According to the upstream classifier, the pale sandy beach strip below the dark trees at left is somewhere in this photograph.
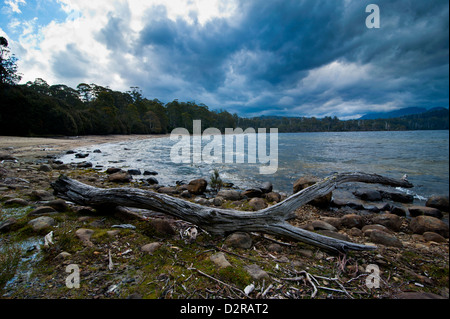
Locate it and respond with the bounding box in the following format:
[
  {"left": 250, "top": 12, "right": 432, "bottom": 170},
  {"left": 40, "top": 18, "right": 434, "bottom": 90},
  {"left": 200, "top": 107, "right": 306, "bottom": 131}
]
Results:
[{"left": 0, "top": 135, "right": 168, "bottom": 158}]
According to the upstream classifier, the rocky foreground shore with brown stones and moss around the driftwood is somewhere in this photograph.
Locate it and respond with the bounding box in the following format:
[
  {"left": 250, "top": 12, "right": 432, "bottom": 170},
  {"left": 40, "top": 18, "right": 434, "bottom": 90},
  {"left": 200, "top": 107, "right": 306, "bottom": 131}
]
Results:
[{"left": 0, "top": 139, "right": 449, "bottom": 299}]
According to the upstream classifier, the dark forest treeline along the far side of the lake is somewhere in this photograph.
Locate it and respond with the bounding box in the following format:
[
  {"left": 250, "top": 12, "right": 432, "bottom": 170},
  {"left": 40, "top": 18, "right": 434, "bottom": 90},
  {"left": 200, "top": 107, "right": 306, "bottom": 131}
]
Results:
[{"left": 0, "top": 79, "right": 449, "bottom": 136}]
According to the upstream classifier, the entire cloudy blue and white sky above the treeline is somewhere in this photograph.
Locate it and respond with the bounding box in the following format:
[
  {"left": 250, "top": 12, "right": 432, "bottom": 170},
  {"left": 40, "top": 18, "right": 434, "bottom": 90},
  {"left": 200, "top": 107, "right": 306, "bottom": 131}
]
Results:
[{"left": 0, "top": 0, "right": 449, "bottom": 119}]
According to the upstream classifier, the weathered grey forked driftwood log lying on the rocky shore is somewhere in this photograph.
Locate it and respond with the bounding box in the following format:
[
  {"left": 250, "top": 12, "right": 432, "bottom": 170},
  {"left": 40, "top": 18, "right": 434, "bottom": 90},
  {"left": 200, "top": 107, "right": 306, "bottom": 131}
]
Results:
[{"left": 51, "top": 173, "right": 413, "bottom": 253}]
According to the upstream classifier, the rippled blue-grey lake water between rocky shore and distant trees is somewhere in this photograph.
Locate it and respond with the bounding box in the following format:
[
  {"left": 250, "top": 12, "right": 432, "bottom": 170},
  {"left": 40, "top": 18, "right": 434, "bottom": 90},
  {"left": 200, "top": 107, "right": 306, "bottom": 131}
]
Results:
[{"left": 61, "top": 131, "right": 449, "bottom": 198}]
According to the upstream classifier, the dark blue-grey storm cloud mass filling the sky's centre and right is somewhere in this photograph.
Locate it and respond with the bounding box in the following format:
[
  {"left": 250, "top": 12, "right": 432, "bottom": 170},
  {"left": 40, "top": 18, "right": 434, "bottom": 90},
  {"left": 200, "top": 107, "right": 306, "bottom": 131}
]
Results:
[{"left": 96, "top": 0, "right": 449, "bottom": 116}]
